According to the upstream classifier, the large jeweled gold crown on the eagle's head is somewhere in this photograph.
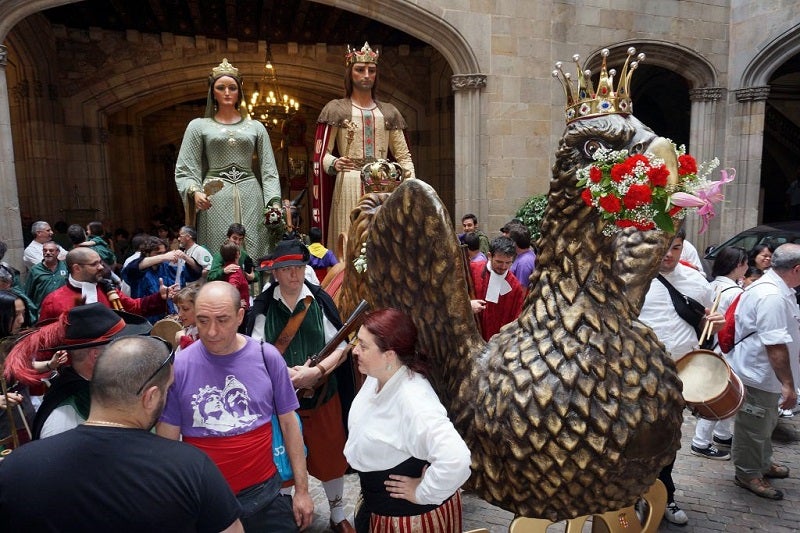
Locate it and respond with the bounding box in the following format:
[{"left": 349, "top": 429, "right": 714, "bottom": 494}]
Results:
[{"left": 553, "top": 47, "right": 645, "bottom": 124}]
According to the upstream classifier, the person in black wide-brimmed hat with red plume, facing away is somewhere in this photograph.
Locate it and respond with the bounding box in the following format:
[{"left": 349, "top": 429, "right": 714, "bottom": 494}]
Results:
[{"left": 31, "top": 303, "right": 152, "bottom": 439}]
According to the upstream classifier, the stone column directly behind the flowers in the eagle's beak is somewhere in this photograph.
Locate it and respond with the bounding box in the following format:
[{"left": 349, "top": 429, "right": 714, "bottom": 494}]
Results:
[{"left": 684, "top": 87, "right": 725, "bottom": 252}]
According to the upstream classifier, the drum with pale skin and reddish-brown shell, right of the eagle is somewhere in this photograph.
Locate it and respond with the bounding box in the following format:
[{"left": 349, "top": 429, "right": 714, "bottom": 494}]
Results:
[{"left": 675, "top": 350, "right": 744, "bottom": 420}]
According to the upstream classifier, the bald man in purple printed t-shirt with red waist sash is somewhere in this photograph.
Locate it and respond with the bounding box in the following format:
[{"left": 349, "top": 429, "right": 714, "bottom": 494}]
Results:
[{"left": 156, "top": 281, "right": 314, "bottom": 531}]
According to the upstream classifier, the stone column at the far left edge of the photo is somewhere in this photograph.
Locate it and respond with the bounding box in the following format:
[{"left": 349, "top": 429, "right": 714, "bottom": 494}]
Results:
[{"left": 0, "top": 44, "right": 24, "bottom": 270}]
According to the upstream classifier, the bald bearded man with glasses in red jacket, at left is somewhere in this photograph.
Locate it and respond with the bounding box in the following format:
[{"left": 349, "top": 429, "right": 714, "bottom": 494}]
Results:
[{"left": 39, "top": 247, "right": 168, "bottom": 322}]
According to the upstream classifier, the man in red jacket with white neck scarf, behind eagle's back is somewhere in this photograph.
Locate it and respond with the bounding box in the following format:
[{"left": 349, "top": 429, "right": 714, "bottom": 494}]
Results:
[{"left": 469, "top": 237, "right": 525, "bottom": 341}]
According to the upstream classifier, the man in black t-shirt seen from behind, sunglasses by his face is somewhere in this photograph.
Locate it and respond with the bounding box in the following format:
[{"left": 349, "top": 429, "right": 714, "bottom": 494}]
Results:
[{"left": 0, "top": 336, "right": 243, "bottom": 533}]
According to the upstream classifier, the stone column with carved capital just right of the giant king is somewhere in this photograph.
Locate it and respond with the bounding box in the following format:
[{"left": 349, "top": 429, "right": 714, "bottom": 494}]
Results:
[{"left": 450, "top": 74, "right": 489, "bottom": 227}]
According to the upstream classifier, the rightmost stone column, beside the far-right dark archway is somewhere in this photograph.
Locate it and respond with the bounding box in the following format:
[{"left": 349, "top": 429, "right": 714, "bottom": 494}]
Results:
[{"left": 722, "top": 86, "right": 769, "bottom": 236}]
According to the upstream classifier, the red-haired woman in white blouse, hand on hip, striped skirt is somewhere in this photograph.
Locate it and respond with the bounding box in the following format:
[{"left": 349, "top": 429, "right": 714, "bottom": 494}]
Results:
[{"left": 344, "top": 309, "right": 470, "bottom": 533}]
